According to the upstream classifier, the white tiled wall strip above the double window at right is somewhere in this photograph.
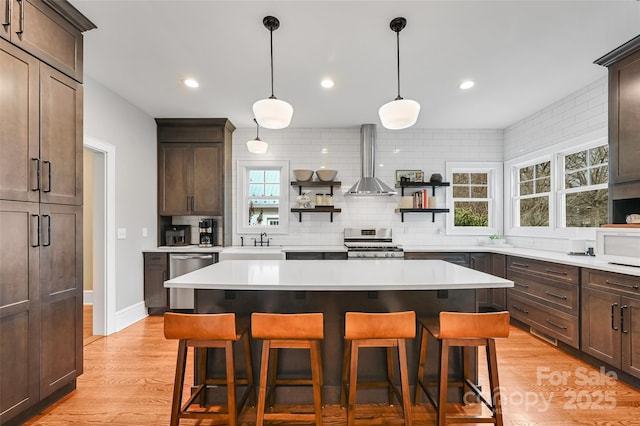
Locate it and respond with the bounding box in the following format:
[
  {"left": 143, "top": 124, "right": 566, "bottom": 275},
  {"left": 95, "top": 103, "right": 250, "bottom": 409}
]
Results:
[{"left": 504, "top": 77, "right": 608, "bottom": 161}]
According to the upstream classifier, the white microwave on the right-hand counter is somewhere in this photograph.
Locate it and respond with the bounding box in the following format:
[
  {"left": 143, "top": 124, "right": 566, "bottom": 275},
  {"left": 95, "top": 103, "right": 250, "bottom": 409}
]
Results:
[{"left": 596, "top": 225, "right": 640, "bottom": 266}]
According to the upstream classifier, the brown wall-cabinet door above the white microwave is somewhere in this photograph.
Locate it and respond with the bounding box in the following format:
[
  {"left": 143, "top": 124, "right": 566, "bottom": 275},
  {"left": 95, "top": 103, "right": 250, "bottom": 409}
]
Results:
[{"left": 609, "top": 52, "right": 640, "bottom": 183}]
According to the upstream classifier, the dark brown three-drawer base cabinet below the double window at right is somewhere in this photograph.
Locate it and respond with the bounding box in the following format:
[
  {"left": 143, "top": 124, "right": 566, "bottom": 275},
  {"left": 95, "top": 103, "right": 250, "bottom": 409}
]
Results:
[{"left": 507, "top": 256, "right": 580, "bottom": 348}]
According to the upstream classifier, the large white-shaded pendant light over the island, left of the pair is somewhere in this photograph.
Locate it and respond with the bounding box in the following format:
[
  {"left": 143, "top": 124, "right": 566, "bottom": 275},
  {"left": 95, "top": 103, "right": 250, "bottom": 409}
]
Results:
[{"left": 253, "top": 16, "right": 293, "bottom": 129}]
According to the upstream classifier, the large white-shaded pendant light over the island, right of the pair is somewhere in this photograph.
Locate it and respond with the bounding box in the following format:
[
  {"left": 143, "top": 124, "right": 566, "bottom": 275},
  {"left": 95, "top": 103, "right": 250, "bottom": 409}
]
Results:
[{"left": 378, "top": 18, "right": 420, "bottom": 130}]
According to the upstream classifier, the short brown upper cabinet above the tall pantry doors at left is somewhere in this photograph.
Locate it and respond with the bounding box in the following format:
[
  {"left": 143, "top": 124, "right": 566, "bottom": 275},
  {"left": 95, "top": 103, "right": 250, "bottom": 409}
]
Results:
[{"left": 0, "top": 0, "right": 95, "bottom": 82}]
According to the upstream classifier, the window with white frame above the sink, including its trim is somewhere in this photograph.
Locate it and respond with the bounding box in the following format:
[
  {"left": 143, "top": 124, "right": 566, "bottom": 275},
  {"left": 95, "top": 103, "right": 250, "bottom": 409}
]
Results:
[{"left": 237, "top": 161, "right": 289, "bottom": 233}]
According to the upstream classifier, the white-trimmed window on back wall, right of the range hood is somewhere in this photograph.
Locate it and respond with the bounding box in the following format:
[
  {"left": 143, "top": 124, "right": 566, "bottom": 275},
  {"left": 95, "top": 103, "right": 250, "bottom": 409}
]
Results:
[{"left": 447, "top": 163, "right": 502, "bottom": 235}]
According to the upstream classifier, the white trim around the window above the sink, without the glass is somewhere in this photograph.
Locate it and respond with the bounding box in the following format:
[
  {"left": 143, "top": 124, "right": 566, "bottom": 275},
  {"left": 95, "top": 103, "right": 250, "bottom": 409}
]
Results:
[{"left": 236, "top": 160, "right": 289, "bottom": 234}]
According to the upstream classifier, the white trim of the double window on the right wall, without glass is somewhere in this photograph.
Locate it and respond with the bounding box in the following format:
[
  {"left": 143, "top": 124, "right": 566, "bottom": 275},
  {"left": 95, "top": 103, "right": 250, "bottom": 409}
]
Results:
[{"left": 504, "top": 128, "right": 608, "bottom": 240}]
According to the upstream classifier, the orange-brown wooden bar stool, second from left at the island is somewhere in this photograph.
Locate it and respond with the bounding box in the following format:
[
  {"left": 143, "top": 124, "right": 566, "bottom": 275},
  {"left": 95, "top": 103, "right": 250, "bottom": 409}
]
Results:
[{"left": 251, "top": 313, "right": 324, "bottom": 426}]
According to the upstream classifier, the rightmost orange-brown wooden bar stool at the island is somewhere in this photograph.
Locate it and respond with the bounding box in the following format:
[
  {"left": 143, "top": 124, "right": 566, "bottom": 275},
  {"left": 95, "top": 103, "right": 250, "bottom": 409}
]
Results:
[{"left": 415, "top": 312, "right": 509, "bottom": 426}]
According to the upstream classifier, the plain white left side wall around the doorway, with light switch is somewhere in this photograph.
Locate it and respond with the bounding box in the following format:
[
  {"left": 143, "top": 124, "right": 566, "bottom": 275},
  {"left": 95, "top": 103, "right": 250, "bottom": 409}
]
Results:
[{"left": 84, "top": 75, "right": 157, "bottom": 311}]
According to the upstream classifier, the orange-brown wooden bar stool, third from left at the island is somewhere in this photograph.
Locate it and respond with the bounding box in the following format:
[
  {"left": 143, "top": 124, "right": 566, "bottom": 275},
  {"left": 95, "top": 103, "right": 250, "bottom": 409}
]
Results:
[{"left": 340, "top": 311, "right": 416, "bottom": 426}]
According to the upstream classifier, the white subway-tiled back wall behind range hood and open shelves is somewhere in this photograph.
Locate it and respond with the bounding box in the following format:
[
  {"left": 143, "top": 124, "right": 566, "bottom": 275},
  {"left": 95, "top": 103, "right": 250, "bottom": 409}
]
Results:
[{"left": 233, "top": 125, "right": 503, "bottom": 245}]
